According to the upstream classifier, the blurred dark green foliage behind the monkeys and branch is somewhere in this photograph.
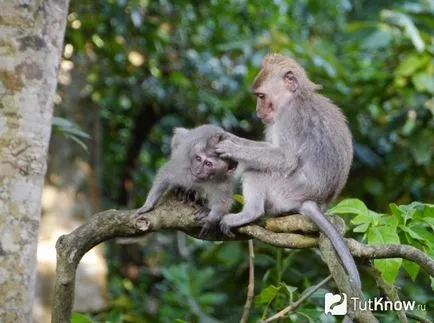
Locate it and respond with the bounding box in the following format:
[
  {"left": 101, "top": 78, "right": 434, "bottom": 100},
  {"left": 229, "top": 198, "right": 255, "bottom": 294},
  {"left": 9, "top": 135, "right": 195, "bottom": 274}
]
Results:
[{"left": 55, "top": 0, "right": 434, "bottom": 322}]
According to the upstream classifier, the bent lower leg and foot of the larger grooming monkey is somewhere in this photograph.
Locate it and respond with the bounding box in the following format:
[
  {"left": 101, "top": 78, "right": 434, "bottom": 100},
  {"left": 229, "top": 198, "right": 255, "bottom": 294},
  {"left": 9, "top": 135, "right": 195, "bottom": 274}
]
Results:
[{"left": 220, "top": 173, "right": 266, "bottom": 236}]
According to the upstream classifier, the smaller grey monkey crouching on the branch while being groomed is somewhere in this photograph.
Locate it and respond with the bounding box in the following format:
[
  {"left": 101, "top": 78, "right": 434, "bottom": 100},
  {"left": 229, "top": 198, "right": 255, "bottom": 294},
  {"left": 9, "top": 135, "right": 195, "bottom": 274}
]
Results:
[{"left": 136, "top": 125, "right": 237, "bottom": 234}]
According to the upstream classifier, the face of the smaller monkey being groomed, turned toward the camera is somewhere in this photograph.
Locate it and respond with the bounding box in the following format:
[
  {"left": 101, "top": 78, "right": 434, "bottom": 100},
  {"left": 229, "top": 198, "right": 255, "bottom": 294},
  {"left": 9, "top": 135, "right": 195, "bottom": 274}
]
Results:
[{"left": 190, "top": 152, "right": 235, "bottom": 182}]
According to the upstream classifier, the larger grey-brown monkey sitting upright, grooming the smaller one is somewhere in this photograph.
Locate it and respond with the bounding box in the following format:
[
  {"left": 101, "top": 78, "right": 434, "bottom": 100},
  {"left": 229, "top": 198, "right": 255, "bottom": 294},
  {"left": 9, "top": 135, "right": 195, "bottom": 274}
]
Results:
[{"left": 217, "top": 54, "right": 361, "bottom": 288}]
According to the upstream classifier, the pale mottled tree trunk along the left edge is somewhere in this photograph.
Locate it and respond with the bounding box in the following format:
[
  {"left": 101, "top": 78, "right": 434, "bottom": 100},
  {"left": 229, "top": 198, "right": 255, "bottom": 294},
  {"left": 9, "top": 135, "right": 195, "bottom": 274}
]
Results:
[{"left": 0, "top": 0, "right": 68, "bottom": 323}]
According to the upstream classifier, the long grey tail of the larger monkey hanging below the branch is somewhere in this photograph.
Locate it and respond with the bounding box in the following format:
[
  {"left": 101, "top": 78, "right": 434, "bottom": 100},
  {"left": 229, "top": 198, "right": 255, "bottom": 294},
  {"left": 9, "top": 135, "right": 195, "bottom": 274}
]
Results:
[{"left": 300, "top": 201, "right": 362, "bottom": 289}]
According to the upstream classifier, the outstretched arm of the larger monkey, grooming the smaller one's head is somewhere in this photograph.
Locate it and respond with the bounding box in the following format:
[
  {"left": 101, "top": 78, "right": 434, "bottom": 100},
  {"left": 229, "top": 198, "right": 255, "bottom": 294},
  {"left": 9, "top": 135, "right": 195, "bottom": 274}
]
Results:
[{"left": 216, "top": 140, "right": 298, "bottom": 175}]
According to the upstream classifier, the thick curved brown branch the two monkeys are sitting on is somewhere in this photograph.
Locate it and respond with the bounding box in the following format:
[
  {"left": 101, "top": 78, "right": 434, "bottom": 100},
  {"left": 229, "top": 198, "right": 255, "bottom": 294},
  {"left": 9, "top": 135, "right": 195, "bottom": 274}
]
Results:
[{"left": 52, "top": 198, "right": 434, "bottom": 323}]
